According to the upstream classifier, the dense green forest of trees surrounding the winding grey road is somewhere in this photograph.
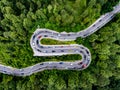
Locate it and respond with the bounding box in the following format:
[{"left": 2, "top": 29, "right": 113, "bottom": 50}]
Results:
[{"left": 0, "top": 0, "right": 120, "bottom": 90}]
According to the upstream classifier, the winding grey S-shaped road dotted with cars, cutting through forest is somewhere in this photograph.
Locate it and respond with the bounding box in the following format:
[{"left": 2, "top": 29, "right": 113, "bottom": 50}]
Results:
[{"left": 0, "top": 5, "right": 120, "bottom": 76}]
